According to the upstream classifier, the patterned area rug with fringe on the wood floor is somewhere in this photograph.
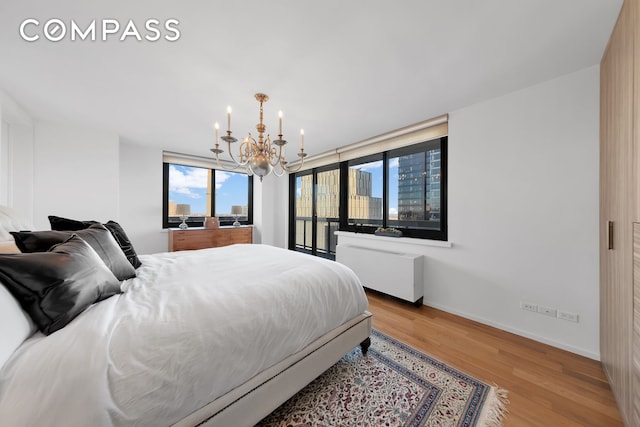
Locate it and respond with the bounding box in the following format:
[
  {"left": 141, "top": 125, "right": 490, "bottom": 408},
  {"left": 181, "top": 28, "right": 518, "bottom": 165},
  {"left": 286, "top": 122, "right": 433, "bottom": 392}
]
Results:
[{"left": 258, "top": 330, "right": 508, "bottom": 427}]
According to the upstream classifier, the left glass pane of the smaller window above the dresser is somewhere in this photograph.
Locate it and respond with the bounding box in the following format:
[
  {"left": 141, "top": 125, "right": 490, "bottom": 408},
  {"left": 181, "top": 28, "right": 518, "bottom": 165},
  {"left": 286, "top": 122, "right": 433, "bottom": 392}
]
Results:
[{"left": 167, "top": 164, "right": 211, "bottom": 226}]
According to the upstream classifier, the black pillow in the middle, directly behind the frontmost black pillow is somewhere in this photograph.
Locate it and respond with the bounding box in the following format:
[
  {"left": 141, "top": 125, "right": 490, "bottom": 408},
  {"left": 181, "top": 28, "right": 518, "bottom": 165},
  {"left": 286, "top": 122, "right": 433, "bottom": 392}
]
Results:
[{"left": 11, "top": 224, "right": 136, "bottom": 280}]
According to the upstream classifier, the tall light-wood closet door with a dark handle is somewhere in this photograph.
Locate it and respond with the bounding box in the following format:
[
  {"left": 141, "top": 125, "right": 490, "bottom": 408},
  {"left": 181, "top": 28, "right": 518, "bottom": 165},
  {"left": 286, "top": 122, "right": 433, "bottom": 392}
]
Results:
[{"left": 600, "top": 0, "right": 640, "bottom": 425}]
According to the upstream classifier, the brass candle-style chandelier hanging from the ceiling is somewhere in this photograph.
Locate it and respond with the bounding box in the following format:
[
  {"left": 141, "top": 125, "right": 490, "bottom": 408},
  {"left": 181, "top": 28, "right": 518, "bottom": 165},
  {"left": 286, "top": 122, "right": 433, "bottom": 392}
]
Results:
[{"left": 211, "top": 93, "right": 307, "bottom": 181}]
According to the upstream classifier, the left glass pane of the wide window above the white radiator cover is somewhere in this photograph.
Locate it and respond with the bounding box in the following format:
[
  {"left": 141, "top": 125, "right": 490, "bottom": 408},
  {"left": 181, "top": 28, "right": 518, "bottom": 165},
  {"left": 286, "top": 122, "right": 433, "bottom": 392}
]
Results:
[{"left": 347, "top": 159, "right": 383, "bottom": 226}]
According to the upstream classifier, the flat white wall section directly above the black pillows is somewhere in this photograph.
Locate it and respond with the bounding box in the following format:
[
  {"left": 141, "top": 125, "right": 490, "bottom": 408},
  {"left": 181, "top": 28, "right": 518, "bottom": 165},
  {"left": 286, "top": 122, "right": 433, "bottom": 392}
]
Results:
[{"left": 34, "top": 122, "right": 120, "bottom": 229}]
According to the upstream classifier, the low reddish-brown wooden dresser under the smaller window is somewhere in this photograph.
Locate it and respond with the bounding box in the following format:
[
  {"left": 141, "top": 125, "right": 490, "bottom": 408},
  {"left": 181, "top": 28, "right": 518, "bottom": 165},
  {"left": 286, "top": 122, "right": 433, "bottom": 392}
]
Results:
[{"left": 169, "top": 226, "right": 253, "bottom": 252}]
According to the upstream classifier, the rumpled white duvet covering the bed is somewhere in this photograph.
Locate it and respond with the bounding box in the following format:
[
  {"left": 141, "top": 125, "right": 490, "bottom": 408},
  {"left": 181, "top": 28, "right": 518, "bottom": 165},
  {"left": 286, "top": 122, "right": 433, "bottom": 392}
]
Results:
[{"left": 0, "top": 245, "right": 367, "bottom": 427}]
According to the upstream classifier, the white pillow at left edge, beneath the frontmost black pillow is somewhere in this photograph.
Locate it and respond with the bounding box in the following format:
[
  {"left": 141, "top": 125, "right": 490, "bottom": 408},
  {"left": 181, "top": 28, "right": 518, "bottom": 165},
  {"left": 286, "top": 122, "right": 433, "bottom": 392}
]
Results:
[{"left": 0, "top": 283, "right": 36, "bottom": 369}]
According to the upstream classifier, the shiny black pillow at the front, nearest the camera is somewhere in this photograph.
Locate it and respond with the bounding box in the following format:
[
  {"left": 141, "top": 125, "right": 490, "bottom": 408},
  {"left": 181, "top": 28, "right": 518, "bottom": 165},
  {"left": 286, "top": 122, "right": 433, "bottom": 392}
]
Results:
[{"left": 0, "top": 234, "right": 121, "bottom": 335}]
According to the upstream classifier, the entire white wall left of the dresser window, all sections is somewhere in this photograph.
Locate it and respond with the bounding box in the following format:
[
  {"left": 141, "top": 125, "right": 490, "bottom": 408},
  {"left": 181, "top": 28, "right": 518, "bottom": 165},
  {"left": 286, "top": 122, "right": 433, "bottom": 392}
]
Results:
[{"left": 0, "top": 103, "right": 167, "bottom": 254}]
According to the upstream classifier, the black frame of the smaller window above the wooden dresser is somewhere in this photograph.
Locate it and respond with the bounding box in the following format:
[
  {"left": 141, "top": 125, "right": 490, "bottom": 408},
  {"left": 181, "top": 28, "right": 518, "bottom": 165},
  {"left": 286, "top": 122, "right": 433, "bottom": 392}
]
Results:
[{"left": 162, "top": 162, "right": 253, "bottom": 229}]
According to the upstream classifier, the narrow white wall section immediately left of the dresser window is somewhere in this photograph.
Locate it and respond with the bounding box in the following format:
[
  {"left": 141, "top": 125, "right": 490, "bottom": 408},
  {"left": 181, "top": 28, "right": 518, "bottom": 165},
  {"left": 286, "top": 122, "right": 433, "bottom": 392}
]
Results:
[{"left": 119, "top": 143, "right": 168, "bottom": 254}]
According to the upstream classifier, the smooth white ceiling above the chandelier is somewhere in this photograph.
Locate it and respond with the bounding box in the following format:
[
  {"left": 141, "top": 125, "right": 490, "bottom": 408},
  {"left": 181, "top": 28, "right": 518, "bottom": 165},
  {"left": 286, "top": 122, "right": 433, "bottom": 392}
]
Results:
[{"left": 0, "top": 0, "right": 622, "bottom": 160}]
